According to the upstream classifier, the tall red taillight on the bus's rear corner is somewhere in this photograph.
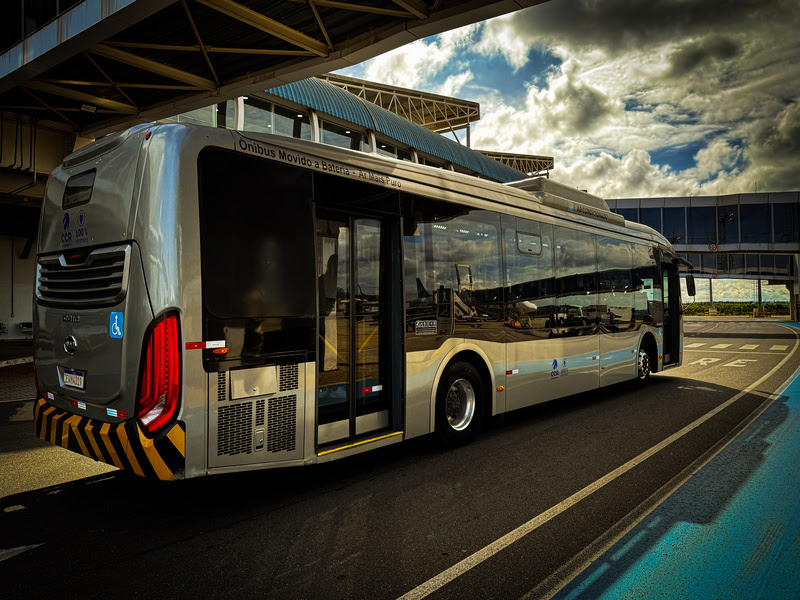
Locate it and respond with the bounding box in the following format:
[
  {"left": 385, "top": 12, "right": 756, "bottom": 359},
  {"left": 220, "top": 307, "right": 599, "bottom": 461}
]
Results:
[{"left": 136, "top": 312, "right": 181, "bottom": 433}]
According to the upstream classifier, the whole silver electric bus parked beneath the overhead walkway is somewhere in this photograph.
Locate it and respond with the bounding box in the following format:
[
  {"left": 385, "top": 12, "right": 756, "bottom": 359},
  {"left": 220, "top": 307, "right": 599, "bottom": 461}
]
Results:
[{"left": 34, "top": 124, "right": 682, "bottom": 480}]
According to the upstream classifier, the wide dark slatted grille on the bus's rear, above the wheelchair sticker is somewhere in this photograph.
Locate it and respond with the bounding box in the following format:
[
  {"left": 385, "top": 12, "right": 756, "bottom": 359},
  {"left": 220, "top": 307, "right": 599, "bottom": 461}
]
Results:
[{"left": 36, "top": 246, "right": 131, "bottom": 308}]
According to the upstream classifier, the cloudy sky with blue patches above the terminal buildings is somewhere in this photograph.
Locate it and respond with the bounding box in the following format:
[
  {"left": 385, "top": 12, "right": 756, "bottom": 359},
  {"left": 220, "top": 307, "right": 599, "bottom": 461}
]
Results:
[{"left": 341, "top": 0, "right": 800, "bottom": 198}]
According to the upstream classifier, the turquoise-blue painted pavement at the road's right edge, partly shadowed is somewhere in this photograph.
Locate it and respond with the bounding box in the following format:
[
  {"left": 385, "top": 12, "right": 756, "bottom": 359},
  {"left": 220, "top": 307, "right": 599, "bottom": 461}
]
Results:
[{"left": 554, "top": 324, "right": 800, "bottom": 600}]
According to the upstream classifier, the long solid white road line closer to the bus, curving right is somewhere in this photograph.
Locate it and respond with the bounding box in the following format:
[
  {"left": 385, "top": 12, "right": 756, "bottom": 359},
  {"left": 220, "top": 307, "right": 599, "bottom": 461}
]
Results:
[{"left": 397, "top": 328, "right": 800, "bottom": 600}]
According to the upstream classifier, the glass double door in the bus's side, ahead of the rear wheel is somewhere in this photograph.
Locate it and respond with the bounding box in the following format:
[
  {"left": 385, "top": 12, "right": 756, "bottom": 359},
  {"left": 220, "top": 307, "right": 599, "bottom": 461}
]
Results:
[{"left": 317, "top": 210, "right": 391, "bottom": 444}]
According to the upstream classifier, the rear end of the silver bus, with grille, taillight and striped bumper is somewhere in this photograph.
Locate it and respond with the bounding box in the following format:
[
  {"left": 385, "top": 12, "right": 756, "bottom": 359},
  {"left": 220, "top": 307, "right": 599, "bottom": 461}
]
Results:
[{"left": 33, "top": 126, "right": 185, "bottom": 480}]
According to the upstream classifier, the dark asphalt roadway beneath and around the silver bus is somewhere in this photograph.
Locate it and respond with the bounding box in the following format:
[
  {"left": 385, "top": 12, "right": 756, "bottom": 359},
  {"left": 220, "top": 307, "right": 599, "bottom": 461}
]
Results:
[{"left": 0, "top": 320, "right": 800, "bottom": 599}]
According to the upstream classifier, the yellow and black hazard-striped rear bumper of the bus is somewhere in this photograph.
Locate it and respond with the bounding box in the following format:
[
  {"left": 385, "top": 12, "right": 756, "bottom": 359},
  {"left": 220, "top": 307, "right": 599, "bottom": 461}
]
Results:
[{"left": 33, "top": 398, "right": 186, "bottom": 481}]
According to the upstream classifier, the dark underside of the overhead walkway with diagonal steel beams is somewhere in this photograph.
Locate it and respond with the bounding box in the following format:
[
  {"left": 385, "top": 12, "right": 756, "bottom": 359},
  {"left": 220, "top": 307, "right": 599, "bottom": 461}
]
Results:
[{"left": 0, "top": 0, "right": 544, "bottom": 137}]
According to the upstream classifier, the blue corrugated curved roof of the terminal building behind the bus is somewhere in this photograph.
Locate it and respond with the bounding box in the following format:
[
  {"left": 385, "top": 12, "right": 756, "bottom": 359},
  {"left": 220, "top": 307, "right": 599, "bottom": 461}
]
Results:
[{"left": 267, "top": 77, "right": 527, "bottom": 183}]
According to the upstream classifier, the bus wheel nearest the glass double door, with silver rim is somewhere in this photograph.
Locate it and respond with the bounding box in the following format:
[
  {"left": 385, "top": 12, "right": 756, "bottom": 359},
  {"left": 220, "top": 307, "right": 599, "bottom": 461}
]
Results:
[{"left": 436, "top": 362, "right": 484, "bottom": 448}]
